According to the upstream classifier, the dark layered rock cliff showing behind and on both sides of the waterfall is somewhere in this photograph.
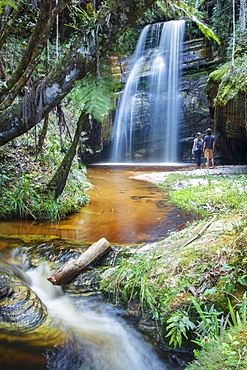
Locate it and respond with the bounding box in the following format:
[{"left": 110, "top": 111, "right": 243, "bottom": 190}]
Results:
[{"left": 90, "top": 39, "right": 220, "bottom": 163}]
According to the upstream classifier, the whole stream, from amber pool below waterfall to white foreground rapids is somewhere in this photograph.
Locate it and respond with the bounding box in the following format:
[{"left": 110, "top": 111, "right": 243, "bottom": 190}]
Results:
[{"left": 0, "top": 166, "right": 196, "bottom": 370}]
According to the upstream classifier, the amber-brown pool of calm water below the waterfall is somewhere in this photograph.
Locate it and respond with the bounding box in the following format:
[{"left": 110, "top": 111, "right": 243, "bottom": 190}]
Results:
[{"left": 0, "top": 166, "right": 195, "bottom": 244}]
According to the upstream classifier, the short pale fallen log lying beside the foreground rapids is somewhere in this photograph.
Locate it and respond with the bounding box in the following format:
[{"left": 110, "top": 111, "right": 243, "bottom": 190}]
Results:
[{"left": 47, "top": 238, "right": 111, "bottom": 285}]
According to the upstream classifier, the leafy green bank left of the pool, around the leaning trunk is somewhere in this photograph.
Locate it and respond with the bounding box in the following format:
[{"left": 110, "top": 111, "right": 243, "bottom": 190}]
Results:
[{"left": 0, "top": 112, "right": 90, "bottom": 221}]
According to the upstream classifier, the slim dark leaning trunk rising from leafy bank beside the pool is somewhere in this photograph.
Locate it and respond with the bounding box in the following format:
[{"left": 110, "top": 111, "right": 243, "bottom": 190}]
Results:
[{"left": 47, "top": 112, "right": 88, "bottom": 198}]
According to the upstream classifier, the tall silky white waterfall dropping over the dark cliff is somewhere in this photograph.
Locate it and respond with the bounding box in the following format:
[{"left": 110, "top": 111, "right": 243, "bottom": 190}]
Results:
[{"left": 111, "top": 20, "right": 184, "bottom": 163}]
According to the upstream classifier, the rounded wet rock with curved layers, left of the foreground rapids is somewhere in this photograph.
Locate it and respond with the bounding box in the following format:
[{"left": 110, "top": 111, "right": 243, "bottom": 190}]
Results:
[{"left": 0, "top": 254, "right": 64, "bottom": 352}]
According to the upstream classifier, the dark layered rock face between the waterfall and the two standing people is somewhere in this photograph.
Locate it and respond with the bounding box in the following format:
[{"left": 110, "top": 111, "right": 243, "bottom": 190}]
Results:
[{"left": 179, "top": 39, "right": 217, "bottom": 161}]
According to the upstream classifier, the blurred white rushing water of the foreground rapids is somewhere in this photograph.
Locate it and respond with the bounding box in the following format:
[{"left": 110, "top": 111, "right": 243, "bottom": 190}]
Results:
[{"left": 27, "top": 263, "right": 170, "bottom": 370}]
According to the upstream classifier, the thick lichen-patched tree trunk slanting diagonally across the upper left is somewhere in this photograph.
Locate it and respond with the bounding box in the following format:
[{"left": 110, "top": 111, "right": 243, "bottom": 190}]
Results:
[{"left": 0, "top": 0, "right": 155, "bottom": 146}]
